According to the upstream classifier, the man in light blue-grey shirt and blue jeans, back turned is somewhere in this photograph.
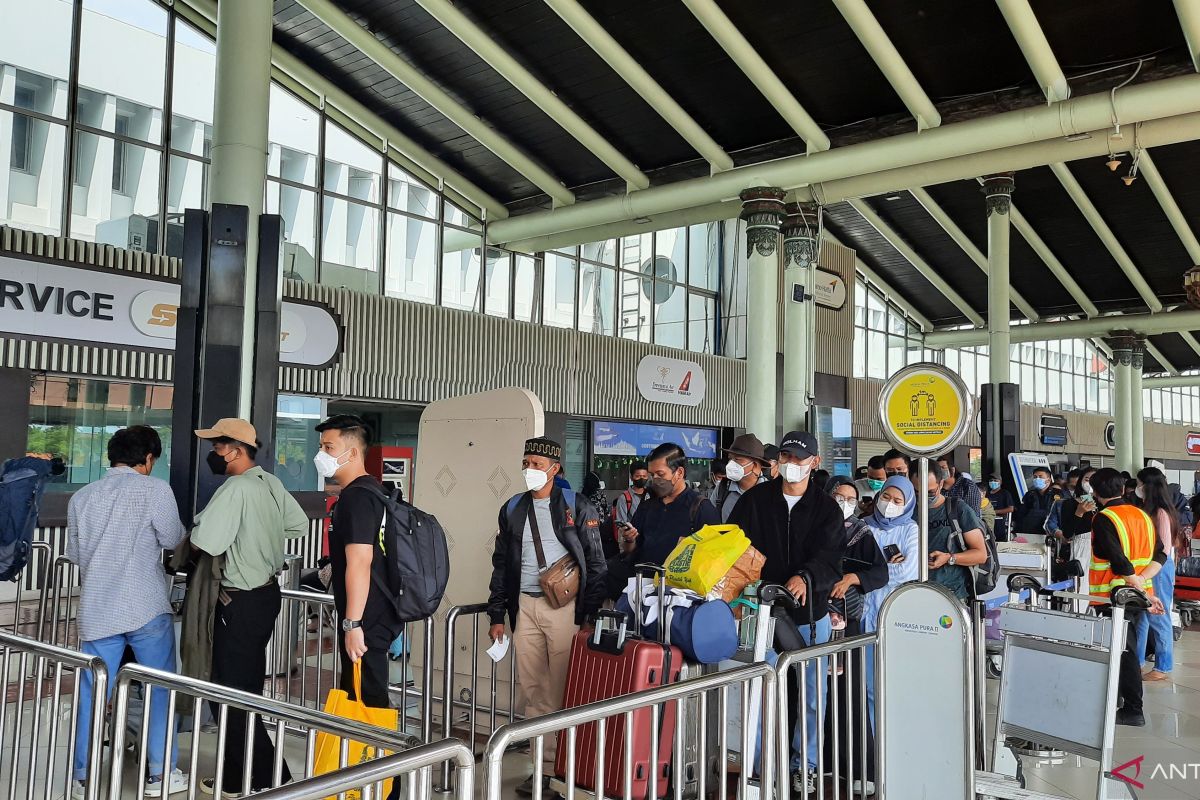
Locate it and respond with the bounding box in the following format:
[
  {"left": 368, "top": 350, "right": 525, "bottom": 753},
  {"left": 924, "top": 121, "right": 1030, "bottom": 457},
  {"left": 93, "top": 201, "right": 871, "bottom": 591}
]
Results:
[{"left": 66, "top": 425, "right": 188, "bottom": 799}]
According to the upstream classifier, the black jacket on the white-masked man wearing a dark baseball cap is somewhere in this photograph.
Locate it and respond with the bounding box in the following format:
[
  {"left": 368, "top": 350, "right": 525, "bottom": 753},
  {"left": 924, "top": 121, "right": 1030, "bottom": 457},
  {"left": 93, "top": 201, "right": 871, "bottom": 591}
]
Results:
[{"left": 730, "top": 477, "right": 846, "bottom": 624}]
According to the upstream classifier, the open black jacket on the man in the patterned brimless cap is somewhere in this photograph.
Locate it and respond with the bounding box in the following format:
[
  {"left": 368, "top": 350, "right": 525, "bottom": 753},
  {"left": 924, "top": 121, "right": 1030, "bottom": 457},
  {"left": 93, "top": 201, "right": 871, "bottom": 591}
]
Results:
[{"left": 487, "top": 486, "right": 607, "bottom": 630}]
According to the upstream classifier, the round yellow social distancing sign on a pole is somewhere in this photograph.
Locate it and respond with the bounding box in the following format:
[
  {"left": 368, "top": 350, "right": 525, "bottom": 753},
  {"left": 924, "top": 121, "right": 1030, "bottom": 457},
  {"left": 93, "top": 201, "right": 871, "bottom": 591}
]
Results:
[{"left": 880, "top": 363, "right": 974, "bottom": 457}]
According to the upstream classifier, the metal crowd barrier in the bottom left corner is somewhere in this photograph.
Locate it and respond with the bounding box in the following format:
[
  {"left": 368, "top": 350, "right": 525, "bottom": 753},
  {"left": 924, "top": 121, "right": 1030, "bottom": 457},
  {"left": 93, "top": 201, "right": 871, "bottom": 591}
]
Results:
[{"left": 0, "top": 633, "right": 108, "bottom": 800}]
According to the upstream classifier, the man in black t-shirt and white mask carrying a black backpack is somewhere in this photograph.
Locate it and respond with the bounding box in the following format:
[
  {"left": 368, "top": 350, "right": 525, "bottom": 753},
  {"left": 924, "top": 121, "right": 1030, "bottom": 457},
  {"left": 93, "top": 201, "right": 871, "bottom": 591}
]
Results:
[{"left": 313, "top": 414, "right": 403, "bottom": 708}]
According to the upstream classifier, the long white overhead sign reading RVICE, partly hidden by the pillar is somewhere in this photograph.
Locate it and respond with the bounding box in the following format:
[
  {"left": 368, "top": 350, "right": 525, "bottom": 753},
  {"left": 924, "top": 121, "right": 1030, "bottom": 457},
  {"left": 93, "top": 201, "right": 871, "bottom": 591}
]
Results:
[{"left": 0, "top": 255, "right": 342, "bottom": 367}]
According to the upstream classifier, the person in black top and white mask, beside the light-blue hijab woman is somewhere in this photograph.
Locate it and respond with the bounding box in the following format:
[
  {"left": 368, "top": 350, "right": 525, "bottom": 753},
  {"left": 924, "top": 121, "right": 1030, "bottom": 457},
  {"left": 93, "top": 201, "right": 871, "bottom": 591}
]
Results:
[{"left": 824, "top": 475, "right": 888, "bottom": 794}]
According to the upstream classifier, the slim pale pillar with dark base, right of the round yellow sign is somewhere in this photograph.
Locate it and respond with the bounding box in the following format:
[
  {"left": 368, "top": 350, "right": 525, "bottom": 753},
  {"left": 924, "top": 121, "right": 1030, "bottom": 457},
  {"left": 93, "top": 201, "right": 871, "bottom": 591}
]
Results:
[{"left": 983, "top": 173, "right": 1015, "bottom": 475}]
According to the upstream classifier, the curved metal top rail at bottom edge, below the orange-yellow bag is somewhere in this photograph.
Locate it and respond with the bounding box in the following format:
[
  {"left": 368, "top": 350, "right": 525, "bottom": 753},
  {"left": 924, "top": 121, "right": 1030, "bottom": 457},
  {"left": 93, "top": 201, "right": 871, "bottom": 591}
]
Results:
[{"left": 254, "top": 739, "right": 475, "bottom": 800}]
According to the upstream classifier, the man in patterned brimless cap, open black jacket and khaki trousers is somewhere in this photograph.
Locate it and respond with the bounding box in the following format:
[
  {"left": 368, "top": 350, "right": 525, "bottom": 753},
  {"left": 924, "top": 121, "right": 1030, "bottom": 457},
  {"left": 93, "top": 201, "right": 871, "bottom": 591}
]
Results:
[{"left": 487, "top": 437, "right": 606, "bottom": 795}]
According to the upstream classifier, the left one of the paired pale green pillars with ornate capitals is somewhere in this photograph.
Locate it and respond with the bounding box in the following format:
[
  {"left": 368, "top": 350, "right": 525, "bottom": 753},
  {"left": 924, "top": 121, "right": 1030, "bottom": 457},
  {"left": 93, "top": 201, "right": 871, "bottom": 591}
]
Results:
[{"left": 739, "top": 186, "right": 784, "bottom": 441}]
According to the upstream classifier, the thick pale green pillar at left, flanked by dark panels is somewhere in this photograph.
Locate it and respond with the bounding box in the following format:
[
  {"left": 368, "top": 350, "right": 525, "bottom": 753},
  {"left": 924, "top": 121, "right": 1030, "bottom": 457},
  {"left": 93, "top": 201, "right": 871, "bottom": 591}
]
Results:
[{"left": 209, "top": 0, "right": 272, "bottom": 419}]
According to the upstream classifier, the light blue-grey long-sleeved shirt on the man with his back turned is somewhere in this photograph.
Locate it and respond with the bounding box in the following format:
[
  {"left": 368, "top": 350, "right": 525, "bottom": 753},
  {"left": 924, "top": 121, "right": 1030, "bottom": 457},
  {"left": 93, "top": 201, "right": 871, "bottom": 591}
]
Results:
[{"left": 66, "top": 467, "right": 185, "bottom": 642}]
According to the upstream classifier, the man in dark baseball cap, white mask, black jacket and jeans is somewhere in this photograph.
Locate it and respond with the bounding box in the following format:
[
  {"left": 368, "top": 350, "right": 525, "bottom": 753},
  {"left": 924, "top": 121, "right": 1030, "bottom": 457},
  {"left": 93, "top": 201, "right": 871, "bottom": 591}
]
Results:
[{"left": 730, "top": 431, "right": 846, "bottom": 795}]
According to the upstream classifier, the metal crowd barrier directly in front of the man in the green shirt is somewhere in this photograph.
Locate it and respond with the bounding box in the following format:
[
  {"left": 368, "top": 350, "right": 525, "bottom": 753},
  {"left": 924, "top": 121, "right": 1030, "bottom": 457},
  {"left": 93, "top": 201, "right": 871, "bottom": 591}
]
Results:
[{"left": 108, "top": 664, "right": 420, "bottom": 800}]
